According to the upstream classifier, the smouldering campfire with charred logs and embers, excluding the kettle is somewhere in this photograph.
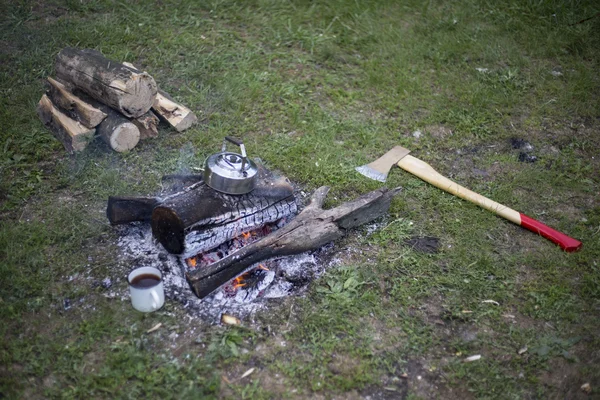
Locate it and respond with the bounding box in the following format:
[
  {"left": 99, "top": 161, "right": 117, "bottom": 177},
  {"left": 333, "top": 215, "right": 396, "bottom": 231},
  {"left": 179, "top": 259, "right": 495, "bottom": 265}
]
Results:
[{"left": 107, "top": 160, "right": 399, "bottom": 310}]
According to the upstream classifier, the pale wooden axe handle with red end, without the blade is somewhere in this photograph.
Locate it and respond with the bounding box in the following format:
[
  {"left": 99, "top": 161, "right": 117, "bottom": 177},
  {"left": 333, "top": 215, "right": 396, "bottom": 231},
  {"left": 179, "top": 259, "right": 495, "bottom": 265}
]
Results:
[{"left": 398, "top": 155, "right": 581, "bottom": 252}]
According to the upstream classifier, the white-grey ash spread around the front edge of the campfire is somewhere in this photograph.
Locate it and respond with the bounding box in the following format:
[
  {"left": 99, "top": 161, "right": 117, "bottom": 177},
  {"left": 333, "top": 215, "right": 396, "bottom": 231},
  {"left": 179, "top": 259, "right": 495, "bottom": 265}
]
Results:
[{"left": 111, "top": 223, "right": 326, "bottom": 324}]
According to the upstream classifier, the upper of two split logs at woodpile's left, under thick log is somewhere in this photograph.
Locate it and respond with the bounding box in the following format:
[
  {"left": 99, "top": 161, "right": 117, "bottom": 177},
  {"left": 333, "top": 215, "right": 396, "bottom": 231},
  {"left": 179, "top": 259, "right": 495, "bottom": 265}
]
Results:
[{"left": 46, "top": 78, "right": 106, "bottom": 128}]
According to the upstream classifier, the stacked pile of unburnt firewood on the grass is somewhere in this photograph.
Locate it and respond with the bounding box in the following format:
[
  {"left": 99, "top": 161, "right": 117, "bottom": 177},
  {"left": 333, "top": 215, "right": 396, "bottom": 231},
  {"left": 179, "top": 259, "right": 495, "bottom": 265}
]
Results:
[{"left": 37, "top": 47, "right": 197, "bottom": 153}]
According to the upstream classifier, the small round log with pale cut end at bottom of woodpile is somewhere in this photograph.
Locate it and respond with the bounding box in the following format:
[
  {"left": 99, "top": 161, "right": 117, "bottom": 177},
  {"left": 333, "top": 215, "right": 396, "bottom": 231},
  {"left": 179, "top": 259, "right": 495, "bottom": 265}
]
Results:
[{"left": 97, "top": 110, "right": 140, "bottom": 152}]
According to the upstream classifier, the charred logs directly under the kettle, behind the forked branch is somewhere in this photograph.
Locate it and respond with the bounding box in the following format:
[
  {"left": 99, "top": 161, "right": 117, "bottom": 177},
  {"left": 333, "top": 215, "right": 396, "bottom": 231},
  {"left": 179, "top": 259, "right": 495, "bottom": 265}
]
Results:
[{"left": 106, "top": 166, "right": 297, "bottom": 257}]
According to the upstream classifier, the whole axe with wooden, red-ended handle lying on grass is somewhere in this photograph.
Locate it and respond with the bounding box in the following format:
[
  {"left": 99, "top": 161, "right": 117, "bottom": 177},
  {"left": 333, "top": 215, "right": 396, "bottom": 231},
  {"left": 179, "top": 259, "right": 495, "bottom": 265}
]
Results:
[{"left": 356, "top": 146, "right": 581, "bottom": 252}]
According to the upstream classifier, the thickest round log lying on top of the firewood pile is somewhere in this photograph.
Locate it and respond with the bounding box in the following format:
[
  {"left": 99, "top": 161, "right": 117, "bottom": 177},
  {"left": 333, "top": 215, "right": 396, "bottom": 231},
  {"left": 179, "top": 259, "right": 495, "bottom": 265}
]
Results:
[{"left": 55, "top": 47, "right": 157, "bottom": 118}]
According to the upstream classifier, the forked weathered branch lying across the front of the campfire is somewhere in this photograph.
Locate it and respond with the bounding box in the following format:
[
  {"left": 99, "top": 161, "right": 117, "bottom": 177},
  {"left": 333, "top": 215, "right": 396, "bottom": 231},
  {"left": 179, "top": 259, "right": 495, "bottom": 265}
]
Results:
[{"left": 186, "top": 187, "right": 400, "bottom": 298}]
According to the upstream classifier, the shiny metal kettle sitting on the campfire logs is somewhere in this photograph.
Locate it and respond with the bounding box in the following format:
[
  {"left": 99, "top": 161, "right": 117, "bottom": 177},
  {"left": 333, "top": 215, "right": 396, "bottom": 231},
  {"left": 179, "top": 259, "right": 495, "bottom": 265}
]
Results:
[{"left": 204, "top": 136, "right": 258, "bottom": 194}]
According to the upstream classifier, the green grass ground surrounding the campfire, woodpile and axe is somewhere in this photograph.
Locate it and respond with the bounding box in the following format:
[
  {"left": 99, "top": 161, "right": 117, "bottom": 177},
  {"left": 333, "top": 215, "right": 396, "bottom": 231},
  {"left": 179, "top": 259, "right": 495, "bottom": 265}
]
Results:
[{"left": 0, "top": 0, "right": 600, "bottom": 399}]
